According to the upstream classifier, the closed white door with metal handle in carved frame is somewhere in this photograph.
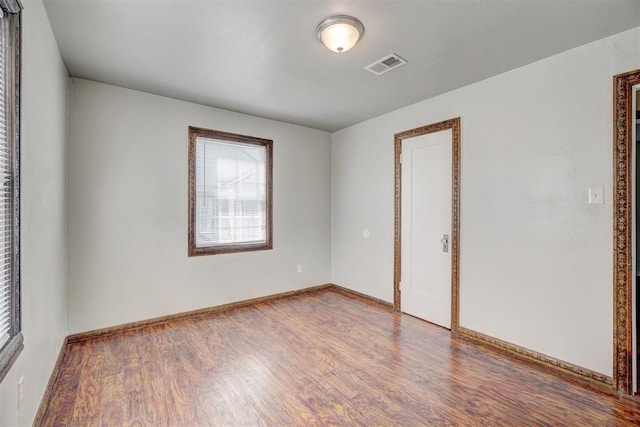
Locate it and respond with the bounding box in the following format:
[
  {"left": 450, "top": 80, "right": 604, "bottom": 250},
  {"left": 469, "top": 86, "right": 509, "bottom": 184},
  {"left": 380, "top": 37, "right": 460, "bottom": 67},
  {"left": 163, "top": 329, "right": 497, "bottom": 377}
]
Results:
[{"left": 400, "top": 129, "right": 452, "bottom": 329}]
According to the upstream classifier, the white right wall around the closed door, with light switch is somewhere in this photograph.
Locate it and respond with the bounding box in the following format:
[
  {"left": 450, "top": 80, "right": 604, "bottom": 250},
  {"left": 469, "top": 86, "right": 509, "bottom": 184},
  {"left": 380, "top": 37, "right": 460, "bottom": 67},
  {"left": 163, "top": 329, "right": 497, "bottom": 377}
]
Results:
[{"left": 332, "top": 28, "right": 640, "bottom": 375}]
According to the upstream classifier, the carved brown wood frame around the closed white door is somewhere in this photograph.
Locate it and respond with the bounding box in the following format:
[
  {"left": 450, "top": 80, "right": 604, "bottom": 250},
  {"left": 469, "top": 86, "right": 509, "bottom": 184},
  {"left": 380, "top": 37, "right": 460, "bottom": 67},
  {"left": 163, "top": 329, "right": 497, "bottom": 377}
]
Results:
[{"left": 393, "top": 117, "right": 460, "bottom": 333}]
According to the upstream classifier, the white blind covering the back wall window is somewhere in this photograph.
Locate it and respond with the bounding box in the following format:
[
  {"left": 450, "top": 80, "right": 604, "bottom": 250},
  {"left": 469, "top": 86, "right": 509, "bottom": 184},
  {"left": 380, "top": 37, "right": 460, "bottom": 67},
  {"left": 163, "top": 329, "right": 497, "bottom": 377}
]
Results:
[{"left": 195, "top": 137, "right": 267, "bottom": 247}]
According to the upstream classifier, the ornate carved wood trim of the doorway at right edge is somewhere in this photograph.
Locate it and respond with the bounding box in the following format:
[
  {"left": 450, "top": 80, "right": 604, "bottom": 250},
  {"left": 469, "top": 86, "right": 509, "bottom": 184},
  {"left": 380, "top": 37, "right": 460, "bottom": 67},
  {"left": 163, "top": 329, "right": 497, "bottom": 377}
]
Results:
[{"left": 613, "top": 70, "right": 640, "bottom": 394}]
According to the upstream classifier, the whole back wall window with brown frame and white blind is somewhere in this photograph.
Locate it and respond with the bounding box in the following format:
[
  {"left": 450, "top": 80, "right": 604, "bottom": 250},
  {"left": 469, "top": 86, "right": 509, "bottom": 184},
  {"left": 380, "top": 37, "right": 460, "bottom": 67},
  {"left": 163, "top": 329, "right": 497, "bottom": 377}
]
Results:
[{"left": 189, "top": 127, "right": 273, "bottom": 256}]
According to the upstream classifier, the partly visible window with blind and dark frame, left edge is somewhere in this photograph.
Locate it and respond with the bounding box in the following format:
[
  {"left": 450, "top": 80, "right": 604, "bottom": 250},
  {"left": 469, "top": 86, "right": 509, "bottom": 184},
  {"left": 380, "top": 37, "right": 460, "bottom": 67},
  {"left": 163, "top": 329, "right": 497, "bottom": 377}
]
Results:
[{"left": 0, "top": 0, "right": 23, "bottom": 381}]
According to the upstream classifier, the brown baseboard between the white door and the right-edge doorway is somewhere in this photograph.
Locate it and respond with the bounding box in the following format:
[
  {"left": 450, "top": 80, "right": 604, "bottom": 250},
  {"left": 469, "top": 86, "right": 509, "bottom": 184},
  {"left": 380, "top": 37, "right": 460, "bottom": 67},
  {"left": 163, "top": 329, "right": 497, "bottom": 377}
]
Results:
[{"left": 458, "top": 326, "right": 613, "bottom": 386}]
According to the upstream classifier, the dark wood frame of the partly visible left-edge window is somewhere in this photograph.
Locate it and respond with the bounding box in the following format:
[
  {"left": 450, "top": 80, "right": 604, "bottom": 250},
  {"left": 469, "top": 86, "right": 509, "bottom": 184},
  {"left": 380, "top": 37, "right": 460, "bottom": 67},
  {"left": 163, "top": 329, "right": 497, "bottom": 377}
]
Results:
[{"left": 0, "top": 0, "right": 24, "bottom": 381}]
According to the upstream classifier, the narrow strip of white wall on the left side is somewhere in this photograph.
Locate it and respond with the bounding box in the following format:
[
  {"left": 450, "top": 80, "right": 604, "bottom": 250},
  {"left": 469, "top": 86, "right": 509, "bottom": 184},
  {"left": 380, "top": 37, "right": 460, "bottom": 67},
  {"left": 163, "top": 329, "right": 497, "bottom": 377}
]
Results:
[{"left": 0, "top": 0, "right": 69, "bottom": 426}]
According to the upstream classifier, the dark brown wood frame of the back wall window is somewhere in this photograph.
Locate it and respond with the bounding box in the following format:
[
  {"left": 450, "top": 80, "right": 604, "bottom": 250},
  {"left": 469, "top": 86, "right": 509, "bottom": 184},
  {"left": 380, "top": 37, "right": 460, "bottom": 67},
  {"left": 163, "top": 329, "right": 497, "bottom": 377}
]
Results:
[{"left": 188, "top": 126, "right": 273, "bottom": 256}]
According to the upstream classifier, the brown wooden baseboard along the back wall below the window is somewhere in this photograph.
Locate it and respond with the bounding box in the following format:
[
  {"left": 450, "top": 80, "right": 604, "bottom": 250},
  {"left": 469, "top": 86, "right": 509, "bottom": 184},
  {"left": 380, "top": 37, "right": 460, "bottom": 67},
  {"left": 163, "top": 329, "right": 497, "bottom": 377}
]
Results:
[{"left": 67, "top": 284, "right": 335, "bottom": 344}]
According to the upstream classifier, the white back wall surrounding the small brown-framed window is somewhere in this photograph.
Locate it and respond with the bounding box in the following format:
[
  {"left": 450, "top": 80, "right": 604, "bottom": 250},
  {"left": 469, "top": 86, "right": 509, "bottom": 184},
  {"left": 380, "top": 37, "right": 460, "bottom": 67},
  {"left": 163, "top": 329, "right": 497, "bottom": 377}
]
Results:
[{"left": 69, "top": 77, "right": 331, "bottom": 333}]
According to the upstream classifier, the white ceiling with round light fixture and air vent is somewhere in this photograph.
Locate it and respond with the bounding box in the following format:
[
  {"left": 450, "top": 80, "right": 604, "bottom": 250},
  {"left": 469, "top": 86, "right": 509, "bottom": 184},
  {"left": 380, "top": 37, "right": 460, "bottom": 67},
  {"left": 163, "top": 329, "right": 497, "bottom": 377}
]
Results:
[{"left": 44, "top": 0, "right": 640, "bottom": 131}]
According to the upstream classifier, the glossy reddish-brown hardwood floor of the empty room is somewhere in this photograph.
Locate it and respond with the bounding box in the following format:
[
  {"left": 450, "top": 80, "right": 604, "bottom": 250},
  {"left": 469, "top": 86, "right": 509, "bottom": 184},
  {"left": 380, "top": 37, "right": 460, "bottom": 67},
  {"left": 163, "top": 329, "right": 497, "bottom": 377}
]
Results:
[{"left": 42, "top": 290, "right": 640, "bottom": 426}]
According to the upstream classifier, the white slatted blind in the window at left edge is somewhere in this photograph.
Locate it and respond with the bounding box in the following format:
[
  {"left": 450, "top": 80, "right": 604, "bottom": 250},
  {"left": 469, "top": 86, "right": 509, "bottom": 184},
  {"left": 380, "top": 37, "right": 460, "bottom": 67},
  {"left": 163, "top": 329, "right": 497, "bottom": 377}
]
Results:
[{"left": 0, "top": 12, "right": 13, "bottom": 348}]
